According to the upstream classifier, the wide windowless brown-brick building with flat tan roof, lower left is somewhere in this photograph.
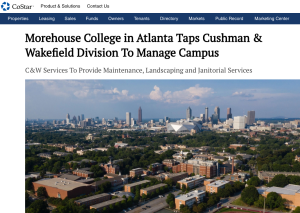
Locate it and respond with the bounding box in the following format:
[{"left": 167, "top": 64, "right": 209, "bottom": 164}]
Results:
[{"left": 32, "top": 178, "right": 92, "bottom": 199}]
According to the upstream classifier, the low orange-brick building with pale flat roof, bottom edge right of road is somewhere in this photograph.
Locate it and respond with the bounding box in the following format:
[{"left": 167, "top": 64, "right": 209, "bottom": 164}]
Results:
[{"left": 175, "top": 190, "right": 205, "bottom": 210}]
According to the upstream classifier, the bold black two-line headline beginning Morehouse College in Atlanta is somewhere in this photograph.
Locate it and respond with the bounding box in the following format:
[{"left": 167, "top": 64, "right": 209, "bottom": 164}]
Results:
[{"left": 25, "top": 33, "right": 262, "bottom": 59}]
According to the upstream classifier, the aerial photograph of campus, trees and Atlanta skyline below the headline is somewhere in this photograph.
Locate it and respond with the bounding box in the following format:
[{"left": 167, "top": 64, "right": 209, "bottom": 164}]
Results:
[{"left": 25, "top": 79, "right": 300, "bottom": 213}]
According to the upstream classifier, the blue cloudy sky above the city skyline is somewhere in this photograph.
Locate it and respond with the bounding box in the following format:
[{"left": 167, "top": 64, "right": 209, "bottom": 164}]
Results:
[{"left": 25, "top": 80, "right": 300, "bottom": 119}]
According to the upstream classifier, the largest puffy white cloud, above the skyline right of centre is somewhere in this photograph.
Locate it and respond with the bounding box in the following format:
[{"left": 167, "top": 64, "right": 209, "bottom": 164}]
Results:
[{"left": 149, "top": 84, "right": 214, "bottom": 105}]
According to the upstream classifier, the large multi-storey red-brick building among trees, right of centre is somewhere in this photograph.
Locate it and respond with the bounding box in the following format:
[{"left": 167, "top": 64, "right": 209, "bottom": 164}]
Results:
[{"left": 172, "top": 159, "right": 219, "bottom": 178}]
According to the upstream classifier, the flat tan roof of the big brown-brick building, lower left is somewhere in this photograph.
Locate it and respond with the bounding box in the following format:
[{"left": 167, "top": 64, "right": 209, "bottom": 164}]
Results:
[{"left": 34, "top": 178, "right": 89, "bottom": 191}]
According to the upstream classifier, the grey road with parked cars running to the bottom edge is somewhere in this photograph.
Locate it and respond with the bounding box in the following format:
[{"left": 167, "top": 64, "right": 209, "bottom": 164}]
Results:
[{"left": 128, "top": 190, "right": 181, "bottom": 213}]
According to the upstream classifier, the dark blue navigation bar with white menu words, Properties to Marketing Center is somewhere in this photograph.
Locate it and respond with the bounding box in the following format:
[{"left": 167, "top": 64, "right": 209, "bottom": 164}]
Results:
[{"left": 0, "top": 13, "right": 300, "bottom": 24}]
